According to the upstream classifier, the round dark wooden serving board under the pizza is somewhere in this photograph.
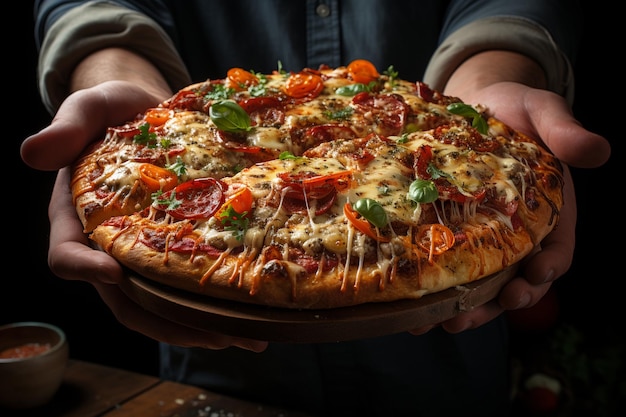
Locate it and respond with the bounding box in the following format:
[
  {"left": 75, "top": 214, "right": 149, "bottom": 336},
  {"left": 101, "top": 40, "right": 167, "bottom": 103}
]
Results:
[{"left": 121, "top": 265, "right": 517, "bottom": 343}]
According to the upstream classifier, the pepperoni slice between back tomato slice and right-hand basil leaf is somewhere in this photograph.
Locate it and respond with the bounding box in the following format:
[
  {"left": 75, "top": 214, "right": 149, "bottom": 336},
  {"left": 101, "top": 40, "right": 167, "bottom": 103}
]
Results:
[{"left": 352, "top": 92, "right": 409, "bottom": 136}]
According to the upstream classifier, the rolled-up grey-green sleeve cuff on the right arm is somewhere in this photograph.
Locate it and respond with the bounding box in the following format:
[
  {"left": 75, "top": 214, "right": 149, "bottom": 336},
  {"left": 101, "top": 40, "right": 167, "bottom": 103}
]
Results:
[{"left": 424, "top": 16, "right": 574, "bottom": 104}]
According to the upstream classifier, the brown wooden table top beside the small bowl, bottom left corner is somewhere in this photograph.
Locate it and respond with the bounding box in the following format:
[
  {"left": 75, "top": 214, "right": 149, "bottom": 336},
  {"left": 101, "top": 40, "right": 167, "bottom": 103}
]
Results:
[{"left": 0, "top": 360, "right": 311, "bottom": 417}]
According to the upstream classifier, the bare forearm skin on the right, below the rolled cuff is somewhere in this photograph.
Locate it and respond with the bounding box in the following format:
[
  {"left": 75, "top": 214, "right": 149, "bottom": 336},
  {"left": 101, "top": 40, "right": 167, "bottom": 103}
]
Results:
[{"left": 444, "top": 50, "right": 547, "bottom": 97}]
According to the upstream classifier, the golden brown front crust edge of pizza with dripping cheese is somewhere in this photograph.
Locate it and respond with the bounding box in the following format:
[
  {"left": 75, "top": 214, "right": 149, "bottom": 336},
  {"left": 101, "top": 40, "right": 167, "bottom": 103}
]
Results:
[{"left": 92, "top": 218, "right": 533, "bottom": 309}]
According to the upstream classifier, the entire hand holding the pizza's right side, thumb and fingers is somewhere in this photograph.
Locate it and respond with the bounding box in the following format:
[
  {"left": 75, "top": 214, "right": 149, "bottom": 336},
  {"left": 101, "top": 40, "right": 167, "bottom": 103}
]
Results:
[{"left": 411, "top": 82, "right": 610, "bottom": 334}]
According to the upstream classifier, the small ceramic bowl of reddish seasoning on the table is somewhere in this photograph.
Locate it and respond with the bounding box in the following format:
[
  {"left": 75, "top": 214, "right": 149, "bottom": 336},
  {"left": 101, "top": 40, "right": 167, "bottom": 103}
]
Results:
[{"left": 0, "top": 322, "right": 69, "bottom": 409}]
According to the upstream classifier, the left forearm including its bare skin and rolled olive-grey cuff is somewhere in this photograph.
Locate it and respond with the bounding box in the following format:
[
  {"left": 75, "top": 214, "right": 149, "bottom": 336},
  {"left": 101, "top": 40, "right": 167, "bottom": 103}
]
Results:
[{"left": 37, "top": 2, "right": 191, "bottom": 114}]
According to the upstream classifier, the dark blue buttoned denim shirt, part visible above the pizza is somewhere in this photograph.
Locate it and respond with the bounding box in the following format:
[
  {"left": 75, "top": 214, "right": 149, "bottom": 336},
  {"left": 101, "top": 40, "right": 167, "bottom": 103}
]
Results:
[{"left": 35, "top": 0, "right": 581, "bottom": 94}]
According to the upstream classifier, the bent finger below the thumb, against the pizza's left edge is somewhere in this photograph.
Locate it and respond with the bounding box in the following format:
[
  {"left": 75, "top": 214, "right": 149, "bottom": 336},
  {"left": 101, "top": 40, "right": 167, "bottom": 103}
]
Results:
[{"left": 48, "top": 168, "right": 123, "bottom": 283}]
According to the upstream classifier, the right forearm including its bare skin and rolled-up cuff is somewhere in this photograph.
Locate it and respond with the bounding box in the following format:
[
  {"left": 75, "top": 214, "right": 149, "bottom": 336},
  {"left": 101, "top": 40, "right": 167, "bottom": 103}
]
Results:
[{"left": 423, "top": 16, "right": 574, "bottom": 104}]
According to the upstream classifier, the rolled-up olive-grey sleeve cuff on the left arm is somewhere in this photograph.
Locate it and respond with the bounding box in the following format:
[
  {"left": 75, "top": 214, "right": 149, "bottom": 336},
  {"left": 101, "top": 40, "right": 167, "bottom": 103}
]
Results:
[{"left": 37, "top": 2, "right": 191, "bottom": 113}]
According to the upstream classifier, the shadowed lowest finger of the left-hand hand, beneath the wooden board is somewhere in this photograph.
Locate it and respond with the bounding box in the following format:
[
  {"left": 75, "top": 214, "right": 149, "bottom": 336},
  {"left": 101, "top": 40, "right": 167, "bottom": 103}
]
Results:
[{"left": 94, "top": 283, "right": 268, "bottom": 352}]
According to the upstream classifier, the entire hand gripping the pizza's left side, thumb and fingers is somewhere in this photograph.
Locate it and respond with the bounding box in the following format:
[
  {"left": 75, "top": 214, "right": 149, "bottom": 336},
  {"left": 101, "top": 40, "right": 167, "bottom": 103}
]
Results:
[{"left": 21, "top": 81, "right": 268, "bottom": 352}]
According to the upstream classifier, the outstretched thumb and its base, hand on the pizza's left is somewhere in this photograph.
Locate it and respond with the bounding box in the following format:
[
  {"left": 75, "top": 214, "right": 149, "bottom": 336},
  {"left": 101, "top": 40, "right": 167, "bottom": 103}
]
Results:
[{"left": 20, "top": 81, "right": 163, "bottom": 171}]
